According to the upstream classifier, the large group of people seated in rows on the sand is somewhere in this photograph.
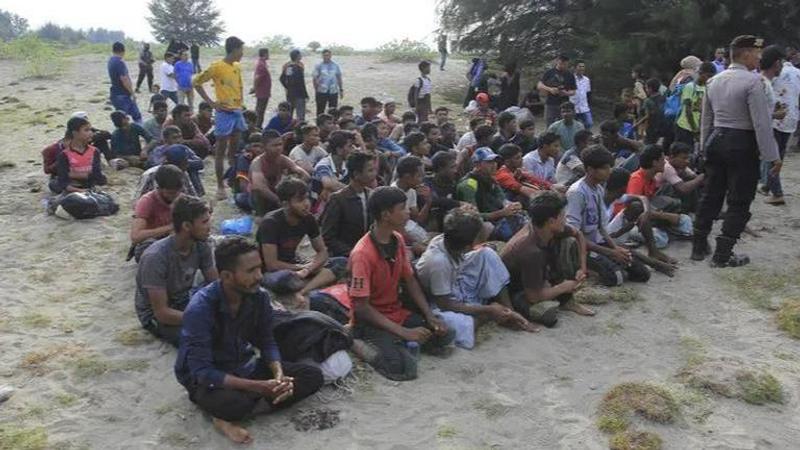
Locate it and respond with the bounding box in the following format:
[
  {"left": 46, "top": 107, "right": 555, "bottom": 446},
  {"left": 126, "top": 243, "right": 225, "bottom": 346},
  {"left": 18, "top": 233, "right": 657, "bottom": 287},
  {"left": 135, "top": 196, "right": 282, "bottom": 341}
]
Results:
[{"left": 43, "top": 90, "right": 703, "bottom": 442}]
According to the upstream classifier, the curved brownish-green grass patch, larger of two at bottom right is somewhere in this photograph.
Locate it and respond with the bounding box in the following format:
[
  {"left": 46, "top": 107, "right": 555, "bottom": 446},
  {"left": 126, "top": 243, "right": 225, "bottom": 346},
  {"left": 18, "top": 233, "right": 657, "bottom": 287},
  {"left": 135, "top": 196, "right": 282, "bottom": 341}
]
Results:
[{"left": 597, "top": 383, "right": 680, "bottom": 433}]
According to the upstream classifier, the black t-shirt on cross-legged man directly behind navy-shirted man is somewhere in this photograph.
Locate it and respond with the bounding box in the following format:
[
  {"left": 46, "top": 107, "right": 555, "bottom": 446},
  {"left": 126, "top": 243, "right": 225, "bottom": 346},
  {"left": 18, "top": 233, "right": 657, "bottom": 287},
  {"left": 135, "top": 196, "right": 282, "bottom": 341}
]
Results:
[{"left": 257, "top": 208, "right": 319, "bottom": 264}]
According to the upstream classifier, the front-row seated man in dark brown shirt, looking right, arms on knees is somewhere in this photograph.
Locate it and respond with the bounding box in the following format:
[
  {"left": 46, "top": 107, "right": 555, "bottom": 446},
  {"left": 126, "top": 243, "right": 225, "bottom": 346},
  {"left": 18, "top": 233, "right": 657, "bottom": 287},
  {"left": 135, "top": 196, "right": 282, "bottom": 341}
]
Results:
[{"left": 500, "top": 192, "right": 594, "bottom": 327}]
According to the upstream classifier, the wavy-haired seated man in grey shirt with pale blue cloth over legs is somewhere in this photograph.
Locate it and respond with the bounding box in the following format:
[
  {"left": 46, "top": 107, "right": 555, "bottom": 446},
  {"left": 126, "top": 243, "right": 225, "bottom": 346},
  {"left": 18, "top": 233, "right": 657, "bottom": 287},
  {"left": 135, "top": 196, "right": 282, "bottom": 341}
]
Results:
[{"left": 416, "top": 209, "right": 537, "bottom": 349}]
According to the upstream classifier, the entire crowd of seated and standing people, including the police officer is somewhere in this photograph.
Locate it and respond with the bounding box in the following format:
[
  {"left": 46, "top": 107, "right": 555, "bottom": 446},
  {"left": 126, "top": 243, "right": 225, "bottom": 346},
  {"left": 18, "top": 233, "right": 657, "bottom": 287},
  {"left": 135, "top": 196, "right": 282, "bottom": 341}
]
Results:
[{"left": 43, "top": 36, "right": 800, "bottom": 442}]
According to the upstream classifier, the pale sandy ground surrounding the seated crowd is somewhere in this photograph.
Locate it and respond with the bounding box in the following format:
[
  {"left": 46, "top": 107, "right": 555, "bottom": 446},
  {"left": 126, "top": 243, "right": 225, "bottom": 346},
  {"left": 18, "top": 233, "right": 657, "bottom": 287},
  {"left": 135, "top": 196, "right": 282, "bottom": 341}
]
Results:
[{"left": 0, "top": 55, "right": 800, "bottom": 449}]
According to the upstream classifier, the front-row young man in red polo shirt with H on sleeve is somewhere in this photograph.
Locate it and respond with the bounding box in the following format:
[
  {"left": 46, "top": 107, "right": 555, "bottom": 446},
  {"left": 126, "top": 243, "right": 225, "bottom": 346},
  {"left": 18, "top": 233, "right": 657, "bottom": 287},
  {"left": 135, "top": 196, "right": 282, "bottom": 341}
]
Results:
[{"left": 348, "top": 186, "right": 455, "bottom": 381}]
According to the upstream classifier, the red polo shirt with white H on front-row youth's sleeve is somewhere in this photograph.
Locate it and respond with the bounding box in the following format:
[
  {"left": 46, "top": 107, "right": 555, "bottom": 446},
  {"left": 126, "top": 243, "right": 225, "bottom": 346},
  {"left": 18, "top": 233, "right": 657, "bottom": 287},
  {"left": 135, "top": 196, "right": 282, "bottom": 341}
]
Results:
[{"left": 348, "top": 232, "right": 414, "bottom": 325}]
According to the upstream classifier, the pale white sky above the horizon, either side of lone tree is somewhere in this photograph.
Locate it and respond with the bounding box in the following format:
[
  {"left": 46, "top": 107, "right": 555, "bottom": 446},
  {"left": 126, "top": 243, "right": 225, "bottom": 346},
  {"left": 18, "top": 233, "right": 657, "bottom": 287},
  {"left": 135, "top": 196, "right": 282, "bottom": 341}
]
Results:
[{"left": 0, "top": 0, "right": 437, "bottom": 50}]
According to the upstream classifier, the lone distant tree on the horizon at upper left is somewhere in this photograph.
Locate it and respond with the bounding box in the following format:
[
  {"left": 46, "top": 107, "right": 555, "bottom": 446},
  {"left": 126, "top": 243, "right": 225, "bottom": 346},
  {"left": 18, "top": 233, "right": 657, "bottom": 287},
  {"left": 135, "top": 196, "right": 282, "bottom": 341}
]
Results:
[{"left": 147, "top": 0, "right": 225, "bottom": 45}]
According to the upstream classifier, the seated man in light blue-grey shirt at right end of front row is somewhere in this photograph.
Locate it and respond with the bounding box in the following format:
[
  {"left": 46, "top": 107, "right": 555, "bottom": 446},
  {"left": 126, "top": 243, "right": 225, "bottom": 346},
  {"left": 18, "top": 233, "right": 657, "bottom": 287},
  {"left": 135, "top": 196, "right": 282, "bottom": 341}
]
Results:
[{"left": 567, "top": 145, "right": 650, "bottom": 286}]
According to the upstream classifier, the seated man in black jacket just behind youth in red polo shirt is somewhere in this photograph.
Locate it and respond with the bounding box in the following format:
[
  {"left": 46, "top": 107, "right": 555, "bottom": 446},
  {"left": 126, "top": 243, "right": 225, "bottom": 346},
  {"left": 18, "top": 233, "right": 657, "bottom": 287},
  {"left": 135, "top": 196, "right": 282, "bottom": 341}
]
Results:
[{"left": 320, "top": 152, "right": 377, "bottom": 256}]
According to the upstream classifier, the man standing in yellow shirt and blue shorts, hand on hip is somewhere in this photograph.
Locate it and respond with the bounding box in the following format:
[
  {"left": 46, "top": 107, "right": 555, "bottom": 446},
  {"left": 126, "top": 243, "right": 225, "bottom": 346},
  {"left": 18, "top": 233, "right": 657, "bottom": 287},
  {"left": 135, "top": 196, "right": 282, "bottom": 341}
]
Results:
[{"left": 192, "top": 36, "right": 247, "bottom": 200}]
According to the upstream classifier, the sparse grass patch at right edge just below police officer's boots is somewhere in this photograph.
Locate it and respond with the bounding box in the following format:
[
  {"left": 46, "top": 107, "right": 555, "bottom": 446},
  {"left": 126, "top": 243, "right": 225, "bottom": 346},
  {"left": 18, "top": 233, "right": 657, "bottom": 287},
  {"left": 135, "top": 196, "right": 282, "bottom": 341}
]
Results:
[{"left": 714, "top": 267, "right": 797, "bottom": 310}]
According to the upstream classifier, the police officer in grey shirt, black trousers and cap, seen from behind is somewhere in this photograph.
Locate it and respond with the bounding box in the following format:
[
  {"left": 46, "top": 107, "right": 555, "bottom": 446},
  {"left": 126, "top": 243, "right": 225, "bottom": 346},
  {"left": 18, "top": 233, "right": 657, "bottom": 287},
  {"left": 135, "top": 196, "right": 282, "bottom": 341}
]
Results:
[{"left": 692, "top": 36, "right": 781, "bottom": 267}]
